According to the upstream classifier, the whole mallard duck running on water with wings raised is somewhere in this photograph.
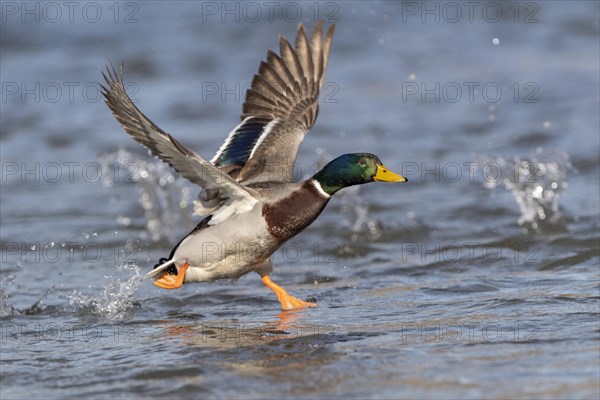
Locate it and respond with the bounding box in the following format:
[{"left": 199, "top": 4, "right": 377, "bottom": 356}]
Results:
[{"left": 102, "top": 21, "right": 406, "bottom": 310}]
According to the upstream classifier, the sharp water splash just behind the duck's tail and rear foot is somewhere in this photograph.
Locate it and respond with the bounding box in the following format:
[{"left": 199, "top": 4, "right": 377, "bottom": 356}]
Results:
[{"left": 69, "top": 262, "right": 143, "bottom": 319}]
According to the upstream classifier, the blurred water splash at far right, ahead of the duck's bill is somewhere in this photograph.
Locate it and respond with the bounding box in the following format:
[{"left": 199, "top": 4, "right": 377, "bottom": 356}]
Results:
[{"left": 482, "top": 148, "right": 573, "bottom": 231}]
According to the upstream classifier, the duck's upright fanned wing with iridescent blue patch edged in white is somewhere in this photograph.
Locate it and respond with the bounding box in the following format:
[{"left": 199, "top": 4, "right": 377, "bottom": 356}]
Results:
[{"left": 211, "top": 21, "right": 335, "bottom": 184}]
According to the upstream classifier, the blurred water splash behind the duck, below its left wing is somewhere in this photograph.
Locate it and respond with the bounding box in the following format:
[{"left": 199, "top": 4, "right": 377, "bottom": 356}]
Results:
[{"left": 100, "top": 149, "right": 193, "bottom": 241}]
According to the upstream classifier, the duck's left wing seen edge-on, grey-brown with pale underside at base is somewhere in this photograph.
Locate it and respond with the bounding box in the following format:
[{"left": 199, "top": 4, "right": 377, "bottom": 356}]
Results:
[{"left": 101, "top": 64, "right": 258, "bottom": 225}]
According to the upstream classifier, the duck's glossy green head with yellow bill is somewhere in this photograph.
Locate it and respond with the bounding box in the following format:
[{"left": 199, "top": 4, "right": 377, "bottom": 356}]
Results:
[{"left": 313, "top": 153, "right": 407, "bottom": 195}]
